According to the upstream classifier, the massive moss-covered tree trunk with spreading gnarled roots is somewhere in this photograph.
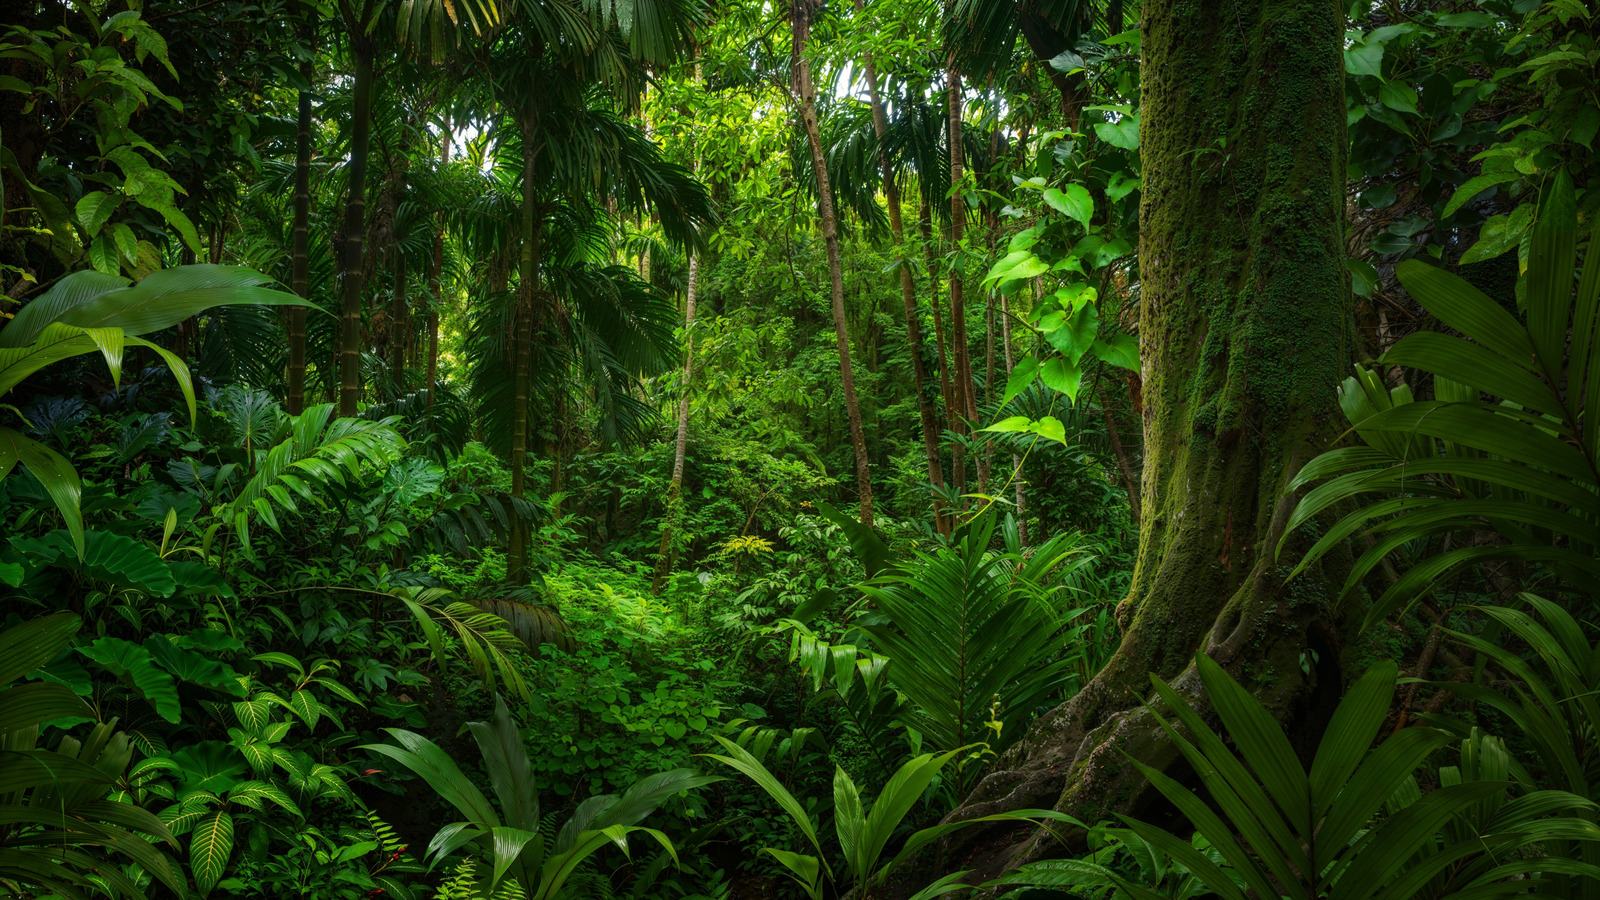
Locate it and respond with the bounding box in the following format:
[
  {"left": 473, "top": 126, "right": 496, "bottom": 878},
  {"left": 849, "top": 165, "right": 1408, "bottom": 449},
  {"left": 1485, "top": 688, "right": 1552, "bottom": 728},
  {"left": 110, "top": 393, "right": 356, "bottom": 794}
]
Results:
[{"left": 952, "top": 0, "right": 1363, "bottom": 876}]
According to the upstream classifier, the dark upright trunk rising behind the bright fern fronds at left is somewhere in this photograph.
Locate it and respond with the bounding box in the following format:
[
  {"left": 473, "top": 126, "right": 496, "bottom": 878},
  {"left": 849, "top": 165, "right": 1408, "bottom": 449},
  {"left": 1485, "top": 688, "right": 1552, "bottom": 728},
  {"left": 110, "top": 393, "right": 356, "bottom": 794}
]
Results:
[{"left": 339, "top": 43, "right": 373, "bottom": 416}]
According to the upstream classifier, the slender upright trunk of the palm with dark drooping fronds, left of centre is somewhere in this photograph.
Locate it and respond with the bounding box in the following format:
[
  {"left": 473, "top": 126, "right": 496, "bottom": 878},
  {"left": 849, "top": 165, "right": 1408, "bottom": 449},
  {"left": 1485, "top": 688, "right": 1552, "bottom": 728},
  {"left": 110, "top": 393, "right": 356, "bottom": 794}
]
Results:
[{"left": 506, "top": 104, "right": 541, "bottom": 580}]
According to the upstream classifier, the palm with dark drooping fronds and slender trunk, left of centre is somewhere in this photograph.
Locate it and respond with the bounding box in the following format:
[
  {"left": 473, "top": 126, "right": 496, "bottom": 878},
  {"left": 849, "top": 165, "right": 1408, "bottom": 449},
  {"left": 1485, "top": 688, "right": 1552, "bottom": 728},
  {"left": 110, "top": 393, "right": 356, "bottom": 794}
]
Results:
[{"left": 466, "top": 76, "right": 712, "bottom": 572}]
